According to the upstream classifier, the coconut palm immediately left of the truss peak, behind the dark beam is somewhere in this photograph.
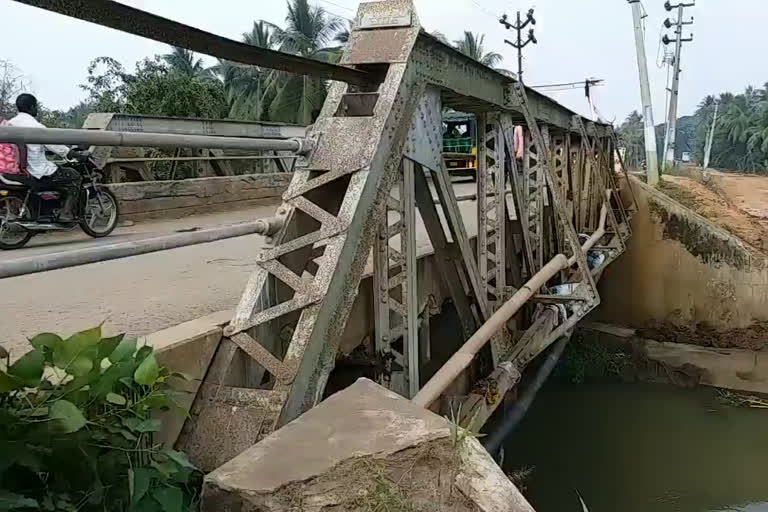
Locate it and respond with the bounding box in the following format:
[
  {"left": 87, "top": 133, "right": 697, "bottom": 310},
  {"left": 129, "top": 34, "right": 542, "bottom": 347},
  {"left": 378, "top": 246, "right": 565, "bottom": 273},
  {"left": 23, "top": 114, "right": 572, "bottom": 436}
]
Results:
[{"left": 266, "top": 0, "right": 346, "bottom": 125}]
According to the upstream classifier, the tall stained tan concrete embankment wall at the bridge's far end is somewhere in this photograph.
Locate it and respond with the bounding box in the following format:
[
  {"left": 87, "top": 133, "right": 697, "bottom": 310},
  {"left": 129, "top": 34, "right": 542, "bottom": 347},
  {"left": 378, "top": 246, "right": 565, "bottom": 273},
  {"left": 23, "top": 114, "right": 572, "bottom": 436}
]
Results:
[{"left": 593, "top": 178, "right": 768, "bottom": 348}]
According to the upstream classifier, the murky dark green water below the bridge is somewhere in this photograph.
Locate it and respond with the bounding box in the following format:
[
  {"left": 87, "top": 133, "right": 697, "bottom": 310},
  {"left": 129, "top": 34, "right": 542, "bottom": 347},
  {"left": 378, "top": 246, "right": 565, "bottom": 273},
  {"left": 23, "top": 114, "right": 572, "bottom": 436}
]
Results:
[{"left": 505, "top": 383, "right": 768, "bottom": 512}]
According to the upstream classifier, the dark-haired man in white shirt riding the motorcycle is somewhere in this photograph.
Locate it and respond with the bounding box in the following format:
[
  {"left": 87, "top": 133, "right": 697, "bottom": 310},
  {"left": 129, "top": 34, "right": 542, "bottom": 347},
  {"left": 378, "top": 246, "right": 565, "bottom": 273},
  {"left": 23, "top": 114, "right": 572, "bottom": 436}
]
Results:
[{"left": 8, "top": 93, "right": 82, "bottom": 222}]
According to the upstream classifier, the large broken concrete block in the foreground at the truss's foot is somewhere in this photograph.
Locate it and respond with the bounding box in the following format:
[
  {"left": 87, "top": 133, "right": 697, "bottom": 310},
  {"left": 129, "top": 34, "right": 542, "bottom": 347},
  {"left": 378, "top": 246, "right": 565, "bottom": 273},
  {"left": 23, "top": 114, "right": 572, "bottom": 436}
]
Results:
[{"left": 202, "top": 379, "right": 533, "bottom": 512}]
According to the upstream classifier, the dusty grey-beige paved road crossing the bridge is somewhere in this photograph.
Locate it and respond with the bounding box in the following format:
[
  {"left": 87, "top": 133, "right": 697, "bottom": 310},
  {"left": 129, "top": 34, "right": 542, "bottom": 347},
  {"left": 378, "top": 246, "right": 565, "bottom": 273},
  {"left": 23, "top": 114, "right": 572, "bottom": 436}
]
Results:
[{"left": 0, "top": 183, "right": 476, "bottom": 356}]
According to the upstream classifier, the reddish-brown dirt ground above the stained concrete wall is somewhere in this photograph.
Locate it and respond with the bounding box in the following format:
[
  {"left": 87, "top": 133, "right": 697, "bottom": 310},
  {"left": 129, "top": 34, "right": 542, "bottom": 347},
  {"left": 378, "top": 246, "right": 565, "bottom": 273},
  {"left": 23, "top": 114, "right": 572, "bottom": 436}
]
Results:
[{"left": 660, "top": 171, "right": 768, "bottom": 254}]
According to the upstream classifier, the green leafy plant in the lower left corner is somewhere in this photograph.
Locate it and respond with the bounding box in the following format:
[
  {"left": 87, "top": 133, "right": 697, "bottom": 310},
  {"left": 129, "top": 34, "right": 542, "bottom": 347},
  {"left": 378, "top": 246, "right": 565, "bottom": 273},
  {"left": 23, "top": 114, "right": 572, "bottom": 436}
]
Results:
[{"left": 0, "top": 326, "right": 200, "bottom": 512}]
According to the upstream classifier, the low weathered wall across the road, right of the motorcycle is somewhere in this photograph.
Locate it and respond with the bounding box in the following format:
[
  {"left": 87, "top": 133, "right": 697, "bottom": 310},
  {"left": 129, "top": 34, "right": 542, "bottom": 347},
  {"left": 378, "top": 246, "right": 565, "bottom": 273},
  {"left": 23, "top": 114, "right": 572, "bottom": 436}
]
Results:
[{"left": 109, "top": 173, "right": 293, "bottom": 220}]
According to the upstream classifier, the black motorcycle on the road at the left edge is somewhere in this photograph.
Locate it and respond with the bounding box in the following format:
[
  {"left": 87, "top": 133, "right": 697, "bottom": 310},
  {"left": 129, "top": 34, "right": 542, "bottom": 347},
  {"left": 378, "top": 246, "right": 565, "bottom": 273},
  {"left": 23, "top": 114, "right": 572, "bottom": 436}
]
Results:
[{"left": 0, "top": 151, "right": 120, "bottom": 250}]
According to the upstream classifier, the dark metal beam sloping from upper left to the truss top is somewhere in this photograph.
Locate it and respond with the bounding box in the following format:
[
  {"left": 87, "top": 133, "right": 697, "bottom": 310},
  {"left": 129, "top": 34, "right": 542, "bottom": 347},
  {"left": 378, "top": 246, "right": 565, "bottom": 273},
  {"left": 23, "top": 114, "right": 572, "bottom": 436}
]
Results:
[{"left": 16, "top": 0, "right": 371, "bottom": 85}]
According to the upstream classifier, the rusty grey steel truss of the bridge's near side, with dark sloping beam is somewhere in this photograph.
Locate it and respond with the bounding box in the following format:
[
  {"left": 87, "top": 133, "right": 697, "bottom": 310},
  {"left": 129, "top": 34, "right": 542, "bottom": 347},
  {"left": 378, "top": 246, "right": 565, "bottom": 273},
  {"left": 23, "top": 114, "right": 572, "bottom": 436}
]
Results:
[{"left": 10, "top": 0, "right": 636, "bottom": 458}]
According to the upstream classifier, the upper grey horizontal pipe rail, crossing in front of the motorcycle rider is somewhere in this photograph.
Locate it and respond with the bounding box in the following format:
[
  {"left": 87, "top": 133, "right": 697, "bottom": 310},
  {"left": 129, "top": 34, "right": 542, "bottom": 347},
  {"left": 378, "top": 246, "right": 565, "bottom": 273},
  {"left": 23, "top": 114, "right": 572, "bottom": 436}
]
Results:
[{"left": 0, "top": 126, "right": 303, "bottom": 153}]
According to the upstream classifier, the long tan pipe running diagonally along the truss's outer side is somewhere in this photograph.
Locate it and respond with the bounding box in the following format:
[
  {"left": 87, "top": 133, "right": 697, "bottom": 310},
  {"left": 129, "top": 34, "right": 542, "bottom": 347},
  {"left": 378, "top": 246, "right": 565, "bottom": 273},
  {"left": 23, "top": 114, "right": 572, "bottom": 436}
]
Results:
[{"left": 413, "top": 190, "right": 611, "bottom": 407}]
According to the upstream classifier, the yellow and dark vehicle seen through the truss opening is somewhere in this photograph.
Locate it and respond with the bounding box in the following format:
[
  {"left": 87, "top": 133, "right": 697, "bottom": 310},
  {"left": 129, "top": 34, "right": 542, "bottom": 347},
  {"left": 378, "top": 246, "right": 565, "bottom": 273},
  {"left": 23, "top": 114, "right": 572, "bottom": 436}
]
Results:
[{"left": 443, "top": 112, "right": 477, "bottom": 178}]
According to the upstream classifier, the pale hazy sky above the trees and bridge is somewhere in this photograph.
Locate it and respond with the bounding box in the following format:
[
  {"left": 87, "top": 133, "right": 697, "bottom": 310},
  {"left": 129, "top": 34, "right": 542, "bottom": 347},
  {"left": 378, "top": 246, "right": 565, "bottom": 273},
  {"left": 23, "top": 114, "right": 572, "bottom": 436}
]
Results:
[{"left": 0, "top": 0, "right": 768, "bottom": 124}]
